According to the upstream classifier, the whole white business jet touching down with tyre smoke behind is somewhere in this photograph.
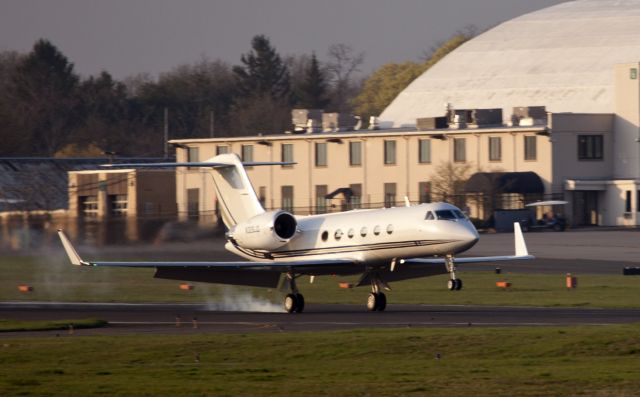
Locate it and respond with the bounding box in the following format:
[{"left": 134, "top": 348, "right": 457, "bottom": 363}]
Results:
[{"left": 58, "top": 154, "right": 533, "bottom": 313}]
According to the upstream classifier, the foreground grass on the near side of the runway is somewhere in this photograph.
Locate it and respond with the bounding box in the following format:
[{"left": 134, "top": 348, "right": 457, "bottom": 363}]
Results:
[{"left": 0, "top": 325, "right": 640, "bottom": 396}]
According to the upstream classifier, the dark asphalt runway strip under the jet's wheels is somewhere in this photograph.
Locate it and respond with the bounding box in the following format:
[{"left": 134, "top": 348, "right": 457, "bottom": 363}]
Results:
[{"left": 0, "top": 302, "right": 640, "bottom": 338}]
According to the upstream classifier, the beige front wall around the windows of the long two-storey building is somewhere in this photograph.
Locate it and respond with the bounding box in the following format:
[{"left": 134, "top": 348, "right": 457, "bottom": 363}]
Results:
[{"left": 173, "top": 126, "right": 552, "bottom": 223}]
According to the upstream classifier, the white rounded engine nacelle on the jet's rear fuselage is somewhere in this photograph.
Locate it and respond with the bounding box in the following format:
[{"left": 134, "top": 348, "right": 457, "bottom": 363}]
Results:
[{"left": 228, "top": 210, "right": 298, "bottom": 251}]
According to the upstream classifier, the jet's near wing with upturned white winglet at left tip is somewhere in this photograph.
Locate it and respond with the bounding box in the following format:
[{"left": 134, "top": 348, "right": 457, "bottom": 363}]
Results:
[{"left": 58, "top": 230, "right": 360, "bottom": 288}]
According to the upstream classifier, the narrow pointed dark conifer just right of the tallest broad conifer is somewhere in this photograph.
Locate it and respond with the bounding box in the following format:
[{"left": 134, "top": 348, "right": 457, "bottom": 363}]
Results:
[{"left": 294, "top": 53, "right": 329, "bottom": 109}]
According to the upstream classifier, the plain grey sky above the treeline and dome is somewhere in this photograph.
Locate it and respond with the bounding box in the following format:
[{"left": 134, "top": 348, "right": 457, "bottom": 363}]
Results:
[{"left": 0, "top": 0, "right": 564, "bottom": 79}]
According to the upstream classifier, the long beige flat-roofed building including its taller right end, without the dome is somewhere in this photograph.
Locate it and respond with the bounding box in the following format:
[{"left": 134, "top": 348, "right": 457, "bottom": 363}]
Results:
[{"left": 171, "top": 64, "right": 640, "bottom": 225}]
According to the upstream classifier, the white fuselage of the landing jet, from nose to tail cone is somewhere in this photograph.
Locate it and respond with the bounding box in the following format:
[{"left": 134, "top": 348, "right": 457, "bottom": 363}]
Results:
[{"left": 226, "top": 203, "right": 478, "bottom": 264}]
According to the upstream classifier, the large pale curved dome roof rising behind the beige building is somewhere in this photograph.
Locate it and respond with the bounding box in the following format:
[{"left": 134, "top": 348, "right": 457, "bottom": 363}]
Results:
[{"left": 380, "top": 0, "right": 640, "bottom": 127}]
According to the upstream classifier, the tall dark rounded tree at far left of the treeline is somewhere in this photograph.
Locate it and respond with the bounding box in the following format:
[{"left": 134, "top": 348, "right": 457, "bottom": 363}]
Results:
[{"left": 8, "top": 39, "right": 82, "bottom": 156}]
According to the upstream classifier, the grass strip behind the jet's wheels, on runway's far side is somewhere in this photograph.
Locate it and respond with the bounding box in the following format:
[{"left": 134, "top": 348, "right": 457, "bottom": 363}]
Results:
[{"left": 0, "top": 256, "right": 640, "bottom": 307}]
